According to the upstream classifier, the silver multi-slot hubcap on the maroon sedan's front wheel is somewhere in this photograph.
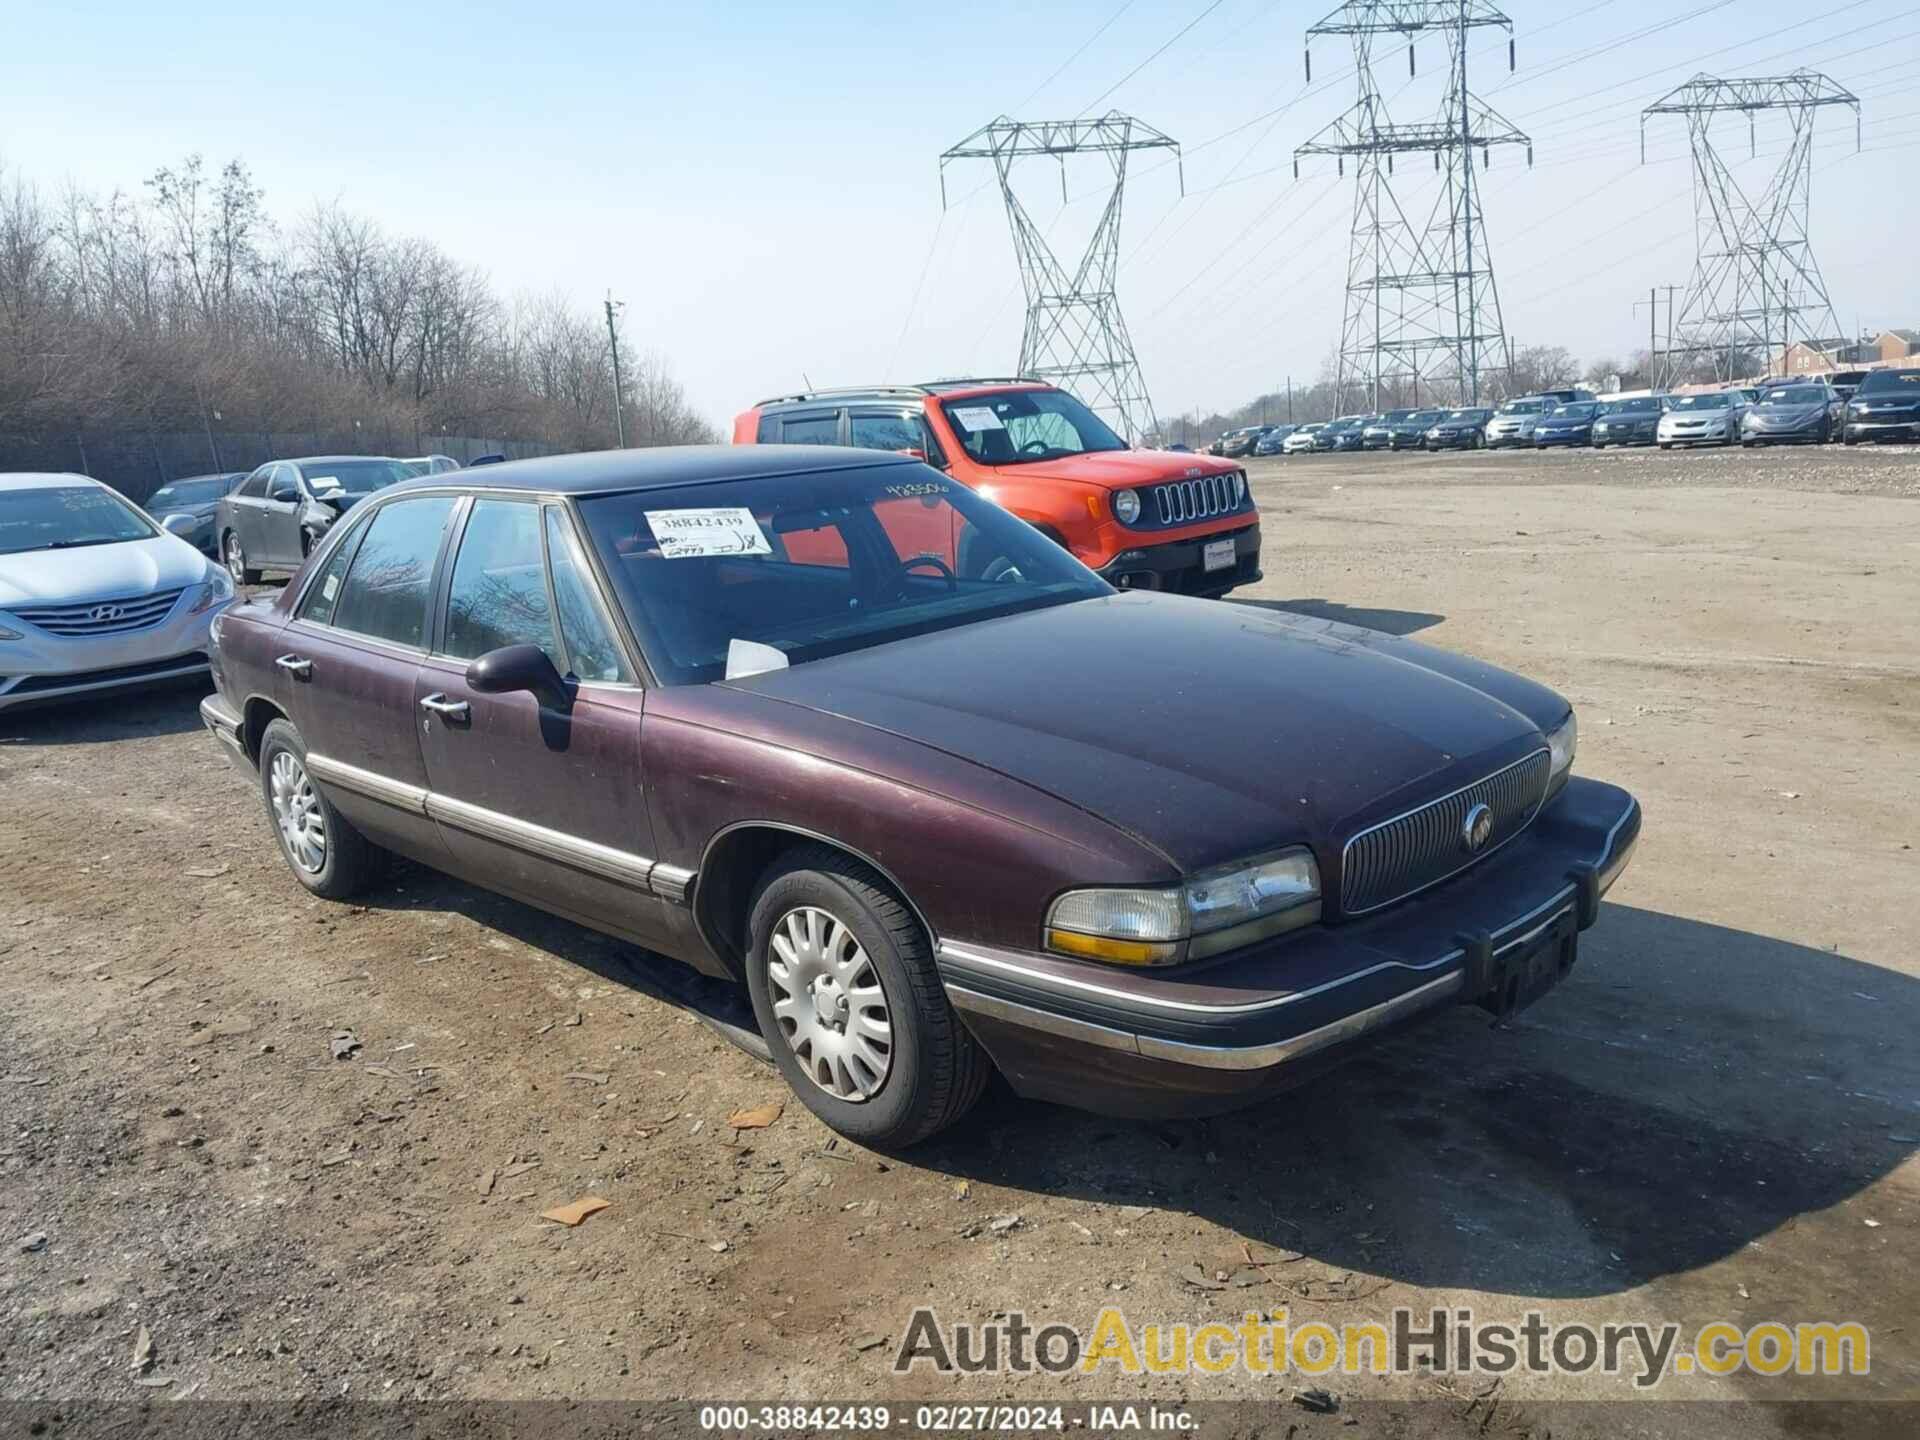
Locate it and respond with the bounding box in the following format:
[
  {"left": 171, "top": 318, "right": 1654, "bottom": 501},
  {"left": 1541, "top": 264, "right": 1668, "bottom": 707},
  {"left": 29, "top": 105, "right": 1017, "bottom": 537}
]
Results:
[{"left": 766, "top": 904, "right": 893, "bottom": 1102}]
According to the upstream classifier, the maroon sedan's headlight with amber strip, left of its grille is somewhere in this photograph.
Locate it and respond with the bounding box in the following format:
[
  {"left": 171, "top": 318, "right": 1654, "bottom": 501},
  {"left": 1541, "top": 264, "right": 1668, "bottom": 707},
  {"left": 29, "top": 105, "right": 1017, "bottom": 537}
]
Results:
[{"left": 1046, "top": 851, "right": 1321, "bottom": 966}]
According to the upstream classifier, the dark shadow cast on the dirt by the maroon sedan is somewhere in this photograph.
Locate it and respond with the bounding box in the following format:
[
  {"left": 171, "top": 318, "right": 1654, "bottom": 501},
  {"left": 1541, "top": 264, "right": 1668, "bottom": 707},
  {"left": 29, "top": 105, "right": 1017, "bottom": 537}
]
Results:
[{"left": 337, "top": 866, "right": 1920, "bottom": 1298}]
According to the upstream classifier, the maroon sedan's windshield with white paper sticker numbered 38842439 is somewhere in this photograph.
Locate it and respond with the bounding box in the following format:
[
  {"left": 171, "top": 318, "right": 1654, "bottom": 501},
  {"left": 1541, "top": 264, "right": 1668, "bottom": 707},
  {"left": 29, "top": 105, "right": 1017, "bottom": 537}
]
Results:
[{"left": 580, "top": 465, "right": 1114, "bottom": 684}]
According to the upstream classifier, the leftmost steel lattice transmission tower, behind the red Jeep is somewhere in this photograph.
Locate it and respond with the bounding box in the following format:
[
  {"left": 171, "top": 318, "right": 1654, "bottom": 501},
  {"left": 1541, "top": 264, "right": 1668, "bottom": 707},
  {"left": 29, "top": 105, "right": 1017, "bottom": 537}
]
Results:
[{"left": 941, "top": 109, "right": 1185, "bottom": 444}]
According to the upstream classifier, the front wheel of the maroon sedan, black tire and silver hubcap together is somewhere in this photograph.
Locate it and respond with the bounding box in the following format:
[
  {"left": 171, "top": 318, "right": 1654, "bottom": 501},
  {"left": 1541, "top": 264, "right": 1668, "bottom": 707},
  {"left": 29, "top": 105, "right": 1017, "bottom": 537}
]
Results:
[{"left": 747, "top": 845, "right": 987, "bottom": 1150}]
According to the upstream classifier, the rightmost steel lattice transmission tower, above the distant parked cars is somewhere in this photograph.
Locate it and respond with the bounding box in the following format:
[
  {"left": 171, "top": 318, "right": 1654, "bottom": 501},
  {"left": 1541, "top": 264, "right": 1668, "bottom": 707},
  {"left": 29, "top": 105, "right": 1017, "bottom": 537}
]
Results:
[{"left": 1640, "top": 69, "right": 1860, "bottom": 386}]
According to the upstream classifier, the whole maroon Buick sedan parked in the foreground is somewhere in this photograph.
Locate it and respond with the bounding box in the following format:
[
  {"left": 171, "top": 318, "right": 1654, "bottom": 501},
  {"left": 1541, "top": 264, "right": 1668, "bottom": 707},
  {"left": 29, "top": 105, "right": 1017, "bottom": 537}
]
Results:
[{"left": 204, "top": 445, "right": 1640, "bottom": 1146}]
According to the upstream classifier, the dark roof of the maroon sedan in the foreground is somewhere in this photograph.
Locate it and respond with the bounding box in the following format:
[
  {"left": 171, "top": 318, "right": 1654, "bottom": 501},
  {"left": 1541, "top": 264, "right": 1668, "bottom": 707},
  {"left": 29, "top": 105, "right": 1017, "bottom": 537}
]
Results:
[{"left": 382, "top": 445, "right": 922, "bottom": 495}]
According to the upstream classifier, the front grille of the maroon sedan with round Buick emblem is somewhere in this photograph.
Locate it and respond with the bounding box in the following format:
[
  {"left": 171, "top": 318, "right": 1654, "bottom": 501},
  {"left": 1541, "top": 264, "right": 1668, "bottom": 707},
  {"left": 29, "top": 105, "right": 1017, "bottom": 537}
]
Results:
[{"left": 1340, "top": 751, "right": 1551, "bottom": 916}]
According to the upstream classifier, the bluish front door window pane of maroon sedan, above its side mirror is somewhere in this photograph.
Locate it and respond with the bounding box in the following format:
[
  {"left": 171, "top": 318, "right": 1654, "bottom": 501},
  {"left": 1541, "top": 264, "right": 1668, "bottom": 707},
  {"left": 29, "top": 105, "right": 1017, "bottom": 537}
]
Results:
[{"left": 440, "top": 499, "right": 561, "bottom": 664}]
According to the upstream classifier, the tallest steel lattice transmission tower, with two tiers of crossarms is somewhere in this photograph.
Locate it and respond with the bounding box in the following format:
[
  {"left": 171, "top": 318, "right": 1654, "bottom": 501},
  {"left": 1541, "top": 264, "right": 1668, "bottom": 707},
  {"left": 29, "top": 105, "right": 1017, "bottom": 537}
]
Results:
[{"left": 1294, "top": 0, "right": 1534, "bottom": 411}]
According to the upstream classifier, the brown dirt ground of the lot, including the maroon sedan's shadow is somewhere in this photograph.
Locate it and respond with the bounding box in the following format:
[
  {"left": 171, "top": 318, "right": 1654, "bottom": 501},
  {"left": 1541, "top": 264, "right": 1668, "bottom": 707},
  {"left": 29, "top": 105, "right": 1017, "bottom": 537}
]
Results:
[{"left": 0, "top": 447, "right": 1920, "bottom": 1440}]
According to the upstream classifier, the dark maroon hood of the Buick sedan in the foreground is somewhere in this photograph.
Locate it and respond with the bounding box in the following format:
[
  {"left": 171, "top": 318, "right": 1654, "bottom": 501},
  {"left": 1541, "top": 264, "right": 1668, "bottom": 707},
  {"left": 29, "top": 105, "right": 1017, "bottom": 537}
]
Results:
[{"left": 730, "top": 593, "right": 1567, "bottom": 870}]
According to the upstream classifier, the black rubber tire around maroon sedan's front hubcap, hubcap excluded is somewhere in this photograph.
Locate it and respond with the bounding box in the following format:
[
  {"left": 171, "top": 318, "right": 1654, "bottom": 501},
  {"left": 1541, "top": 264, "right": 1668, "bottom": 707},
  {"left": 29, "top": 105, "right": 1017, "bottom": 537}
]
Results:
[{"left": 747, "top": 845, "right": 991, "bottom": 1150}]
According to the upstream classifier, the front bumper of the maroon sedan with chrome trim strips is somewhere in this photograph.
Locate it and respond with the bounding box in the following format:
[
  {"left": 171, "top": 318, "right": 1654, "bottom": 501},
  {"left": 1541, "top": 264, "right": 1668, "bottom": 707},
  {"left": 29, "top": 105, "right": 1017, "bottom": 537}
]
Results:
[{"left": 939, "top": 778, "right": 1640, "bottom": 1116}]
